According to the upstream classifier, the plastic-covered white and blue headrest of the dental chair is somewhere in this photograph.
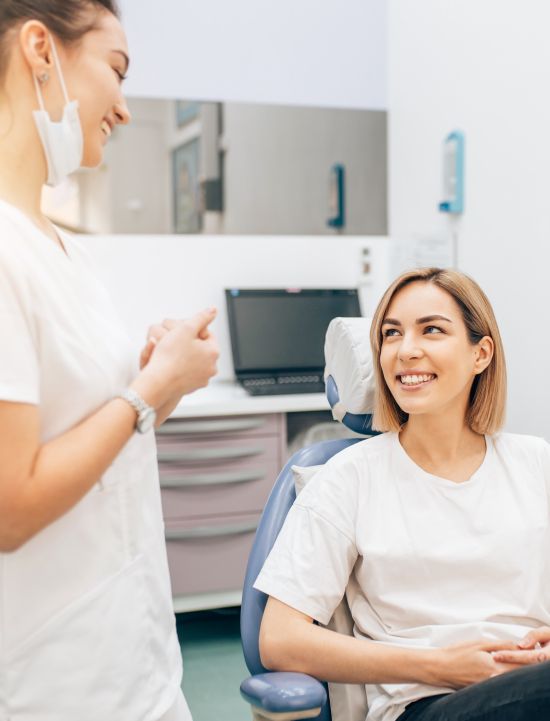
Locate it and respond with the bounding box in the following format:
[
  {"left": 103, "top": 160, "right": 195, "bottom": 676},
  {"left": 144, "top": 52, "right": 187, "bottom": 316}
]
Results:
[{"left": 325, "top": 318, "right": 374, "bottom": 433}]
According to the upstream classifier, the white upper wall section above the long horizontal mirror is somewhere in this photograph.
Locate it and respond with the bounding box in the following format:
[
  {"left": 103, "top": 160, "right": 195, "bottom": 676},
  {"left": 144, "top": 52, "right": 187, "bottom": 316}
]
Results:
[{"left": 120, "top": 0, "right": 386, "bottom": 109}]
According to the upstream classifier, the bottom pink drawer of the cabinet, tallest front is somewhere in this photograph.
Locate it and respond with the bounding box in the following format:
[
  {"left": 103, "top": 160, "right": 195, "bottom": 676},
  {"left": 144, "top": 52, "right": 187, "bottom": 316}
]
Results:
[{"left": 165, "top": 514, "right": 260, "bottom": 596}]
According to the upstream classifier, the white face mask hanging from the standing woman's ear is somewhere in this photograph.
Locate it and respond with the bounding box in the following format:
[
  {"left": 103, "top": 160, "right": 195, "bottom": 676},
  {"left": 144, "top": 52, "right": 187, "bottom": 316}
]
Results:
[{"left": 33, "top": 36, "right": 84, "bottom": 186}]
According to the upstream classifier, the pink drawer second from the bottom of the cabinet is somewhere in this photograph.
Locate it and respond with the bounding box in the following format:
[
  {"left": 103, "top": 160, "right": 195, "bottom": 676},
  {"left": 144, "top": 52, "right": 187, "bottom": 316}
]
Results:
[{"left": 160, "top": 456, "right": 281, "bottom": 521}]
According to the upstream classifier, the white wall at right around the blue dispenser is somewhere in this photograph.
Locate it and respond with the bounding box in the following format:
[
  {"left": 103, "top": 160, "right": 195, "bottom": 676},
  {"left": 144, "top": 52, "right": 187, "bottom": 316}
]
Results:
[{"left": 388, "top": 0, "right": 550, "bottom": 438}]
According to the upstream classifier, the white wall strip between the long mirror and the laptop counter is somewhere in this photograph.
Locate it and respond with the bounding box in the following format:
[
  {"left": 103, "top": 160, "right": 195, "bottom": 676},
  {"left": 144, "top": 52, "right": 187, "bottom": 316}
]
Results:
[{"left": 81, "top": 235, "right": 389, "bottom": 379}]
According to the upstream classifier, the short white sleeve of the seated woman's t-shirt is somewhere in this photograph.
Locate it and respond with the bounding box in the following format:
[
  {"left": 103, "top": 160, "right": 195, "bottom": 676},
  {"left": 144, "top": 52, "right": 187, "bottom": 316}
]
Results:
[{"left": 254, "top": 469, "right": 357, "bottom": 625}]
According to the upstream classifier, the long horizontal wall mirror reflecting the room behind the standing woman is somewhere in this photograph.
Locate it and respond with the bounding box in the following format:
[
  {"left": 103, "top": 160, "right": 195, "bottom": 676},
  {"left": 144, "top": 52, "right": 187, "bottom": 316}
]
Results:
[{"left": 43, "top": 98, "right": 387, "bottom": 235}]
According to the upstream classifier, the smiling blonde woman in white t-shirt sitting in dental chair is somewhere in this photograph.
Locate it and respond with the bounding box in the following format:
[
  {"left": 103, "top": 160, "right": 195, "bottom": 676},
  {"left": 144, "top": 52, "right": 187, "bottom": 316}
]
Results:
[{"left": 255, "top": 269, "right": 550, "bottom": 721}]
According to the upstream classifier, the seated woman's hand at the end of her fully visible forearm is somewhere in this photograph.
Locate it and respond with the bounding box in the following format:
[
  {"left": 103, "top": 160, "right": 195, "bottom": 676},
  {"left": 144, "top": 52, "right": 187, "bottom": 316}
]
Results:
[{"left": 436, "top": 641, "right": 520, "bottom": 688}]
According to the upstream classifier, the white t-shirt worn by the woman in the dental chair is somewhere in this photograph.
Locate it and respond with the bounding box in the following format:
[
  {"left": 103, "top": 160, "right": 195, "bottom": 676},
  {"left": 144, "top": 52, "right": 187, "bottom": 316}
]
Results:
[{"left": 255, "top": 433, "right": 550, "bottom": 721}]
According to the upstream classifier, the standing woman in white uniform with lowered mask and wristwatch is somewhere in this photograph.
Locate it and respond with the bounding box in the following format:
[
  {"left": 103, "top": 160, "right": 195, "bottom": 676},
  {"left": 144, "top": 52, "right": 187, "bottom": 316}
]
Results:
[{"left": 0, "top": 0, "right": 218, "bottom": 721}]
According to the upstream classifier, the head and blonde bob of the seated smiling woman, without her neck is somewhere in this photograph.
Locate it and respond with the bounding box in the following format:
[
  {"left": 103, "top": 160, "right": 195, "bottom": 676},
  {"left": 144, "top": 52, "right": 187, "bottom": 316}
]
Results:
[{"left": 371, "top": 268, "right": 506, "bottom": 433}]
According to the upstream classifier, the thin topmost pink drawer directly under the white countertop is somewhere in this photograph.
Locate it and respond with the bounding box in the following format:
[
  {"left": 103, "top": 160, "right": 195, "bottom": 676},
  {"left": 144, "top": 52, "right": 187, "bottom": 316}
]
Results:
[{"left": 156, "top": 413, "right": 284, "bottom": 446}]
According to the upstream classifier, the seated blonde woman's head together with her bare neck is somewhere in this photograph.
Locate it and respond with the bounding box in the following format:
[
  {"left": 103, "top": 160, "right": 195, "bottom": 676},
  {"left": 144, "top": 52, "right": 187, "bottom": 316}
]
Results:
[{"left": 371, "top": 268, "right": 506, "bottom": 481}]
